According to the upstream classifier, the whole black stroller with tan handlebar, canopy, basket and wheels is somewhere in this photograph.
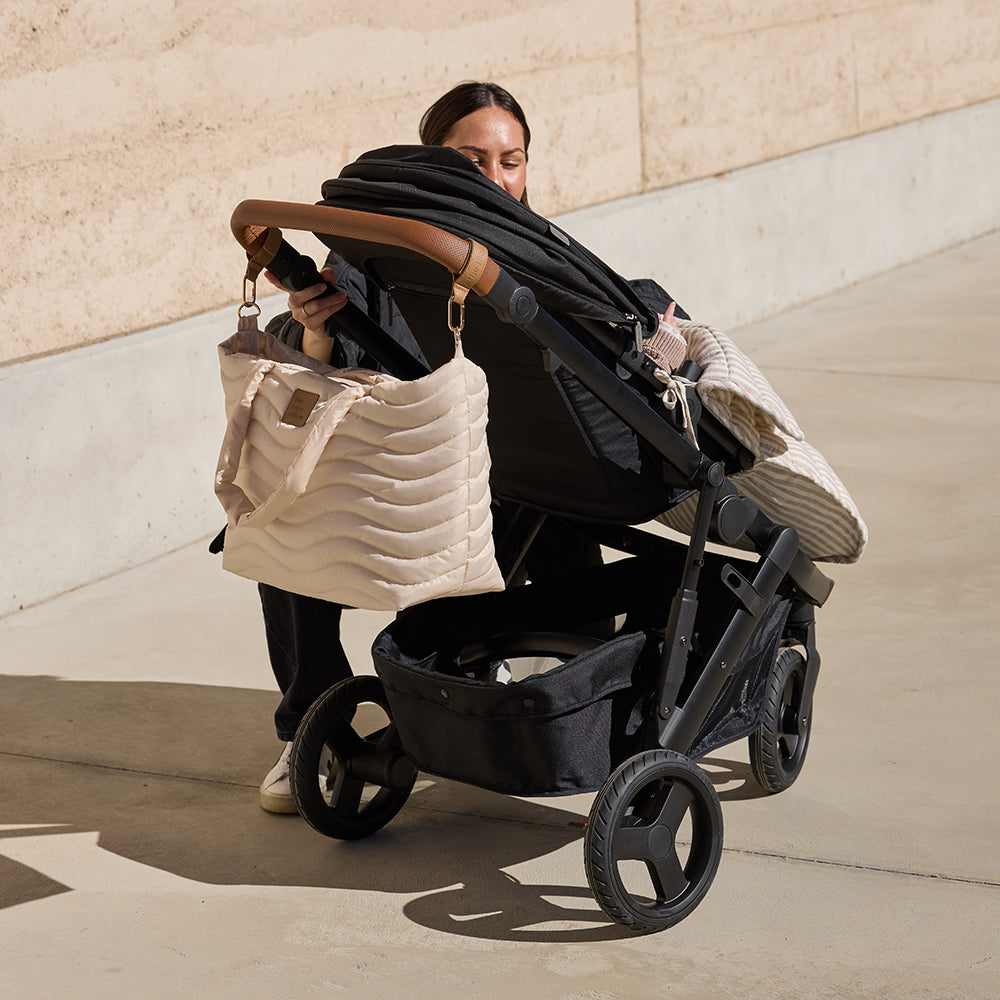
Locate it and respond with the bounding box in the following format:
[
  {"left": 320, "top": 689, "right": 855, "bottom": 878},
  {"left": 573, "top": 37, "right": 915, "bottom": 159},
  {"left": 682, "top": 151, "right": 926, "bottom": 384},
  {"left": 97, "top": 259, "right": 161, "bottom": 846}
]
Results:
[{"left": 232, "top": 147, "right": 848, "bottom": 933}]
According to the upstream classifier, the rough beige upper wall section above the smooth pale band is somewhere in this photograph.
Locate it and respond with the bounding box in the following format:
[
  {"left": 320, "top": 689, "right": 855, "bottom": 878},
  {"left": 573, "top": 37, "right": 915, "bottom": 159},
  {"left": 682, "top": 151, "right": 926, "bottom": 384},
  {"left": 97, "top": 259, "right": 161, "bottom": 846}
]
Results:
[{"left": 0, "top": 0, "right": 1000, "bottom": 363}]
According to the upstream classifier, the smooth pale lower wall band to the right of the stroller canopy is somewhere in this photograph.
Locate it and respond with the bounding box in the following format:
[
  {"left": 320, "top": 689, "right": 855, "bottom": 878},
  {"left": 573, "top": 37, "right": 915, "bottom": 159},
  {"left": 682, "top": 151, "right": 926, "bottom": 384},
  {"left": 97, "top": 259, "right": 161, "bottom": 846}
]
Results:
[{"left": 560, "top": 100, "right": 1000, "bottom": 329}]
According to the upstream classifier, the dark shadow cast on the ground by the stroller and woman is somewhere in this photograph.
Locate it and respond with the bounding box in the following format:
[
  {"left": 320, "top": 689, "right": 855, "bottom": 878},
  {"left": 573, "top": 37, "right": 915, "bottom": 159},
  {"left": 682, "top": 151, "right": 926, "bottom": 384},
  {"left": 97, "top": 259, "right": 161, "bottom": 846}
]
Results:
[{"left": 0, "top": 677, "right": 696, "bottom": 941}]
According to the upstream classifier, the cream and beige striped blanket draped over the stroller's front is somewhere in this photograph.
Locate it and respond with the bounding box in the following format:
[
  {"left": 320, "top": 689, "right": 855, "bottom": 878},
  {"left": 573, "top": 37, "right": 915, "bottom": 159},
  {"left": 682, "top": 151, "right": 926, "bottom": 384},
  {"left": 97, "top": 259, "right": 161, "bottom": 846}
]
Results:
[{"left": 659, "top": 320, "right": 868, "bottom": 563}]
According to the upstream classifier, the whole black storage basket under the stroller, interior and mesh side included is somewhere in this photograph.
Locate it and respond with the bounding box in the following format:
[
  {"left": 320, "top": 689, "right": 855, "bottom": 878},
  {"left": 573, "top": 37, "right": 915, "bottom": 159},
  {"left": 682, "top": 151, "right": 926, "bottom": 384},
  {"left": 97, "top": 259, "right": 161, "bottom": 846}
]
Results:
[{"left": 372, "top": 546, "right": 789, "bottom": 795}]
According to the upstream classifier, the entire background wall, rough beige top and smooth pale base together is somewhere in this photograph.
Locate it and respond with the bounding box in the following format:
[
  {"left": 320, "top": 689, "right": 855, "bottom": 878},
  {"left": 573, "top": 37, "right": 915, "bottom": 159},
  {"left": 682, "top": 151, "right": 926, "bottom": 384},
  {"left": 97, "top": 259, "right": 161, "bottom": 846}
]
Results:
[{"left": 0, "top": 0, "right": 1000, "bottom": 615}]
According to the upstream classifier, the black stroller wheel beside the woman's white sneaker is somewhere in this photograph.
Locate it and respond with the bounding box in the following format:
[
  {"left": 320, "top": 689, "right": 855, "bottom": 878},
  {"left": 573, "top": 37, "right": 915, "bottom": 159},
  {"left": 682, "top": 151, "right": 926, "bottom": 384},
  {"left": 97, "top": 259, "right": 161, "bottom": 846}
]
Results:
[{"left": 290, "top": 676, "right": 417, "bottom": 840}]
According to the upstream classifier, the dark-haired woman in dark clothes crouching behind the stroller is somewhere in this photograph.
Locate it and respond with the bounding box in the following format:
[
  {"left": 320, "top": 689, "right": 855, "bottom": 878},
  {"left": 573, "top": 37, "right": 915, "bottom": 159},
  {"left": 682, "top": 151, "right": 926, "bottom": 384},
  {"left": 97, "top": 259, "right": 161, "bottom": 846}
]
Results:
[{"left": 259, "top": 83, "right": 544, "bottom": 813}]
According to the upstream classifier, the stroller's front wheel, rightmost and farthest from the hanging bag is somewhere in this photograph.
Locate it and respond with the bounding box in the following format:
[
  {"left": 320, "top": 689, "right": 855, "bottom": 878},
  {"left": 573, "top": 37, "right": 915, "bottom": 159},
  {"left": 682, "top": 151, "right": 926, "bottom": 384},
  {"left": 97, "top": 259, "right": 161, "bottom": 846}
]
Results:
[{"left": 750, "top": 648, "right": 812, "bottom": 795}]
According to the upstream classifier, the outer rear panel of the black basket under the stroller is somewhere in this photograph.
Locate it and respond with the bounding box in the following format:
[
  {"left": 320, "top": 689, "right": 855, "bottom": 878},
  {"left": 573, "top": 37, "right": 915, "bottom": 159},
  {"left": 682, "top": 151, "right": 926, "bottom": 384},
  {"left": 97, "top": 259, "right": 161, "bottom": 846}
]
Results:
[{"left": 372, "top": 626, "right": 656, "bottom": 795}]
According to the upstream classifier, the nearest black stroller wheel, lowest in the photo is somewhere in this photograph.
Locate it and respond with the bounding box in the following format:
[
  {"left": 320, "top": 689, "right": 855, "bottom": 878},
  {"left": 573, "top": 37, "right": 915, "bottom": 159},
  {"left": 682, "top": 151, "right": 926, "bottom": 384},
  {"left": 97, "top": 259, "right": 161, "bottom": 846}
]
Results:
[{"left": 584, "top": 749, "right": 722, "bottom": 934}]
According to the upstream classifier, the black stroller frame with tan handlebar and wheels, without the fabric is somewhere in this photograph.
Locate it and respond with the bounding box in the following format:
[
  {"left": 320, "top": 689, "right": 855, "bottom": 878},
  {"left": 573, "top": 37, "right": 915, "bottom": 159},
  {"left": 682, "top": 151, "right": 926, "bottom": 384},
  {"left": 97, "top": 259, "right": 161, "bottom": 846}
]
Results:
[{"left": 232, "top": 189, "right": 833, "bottom": 933}]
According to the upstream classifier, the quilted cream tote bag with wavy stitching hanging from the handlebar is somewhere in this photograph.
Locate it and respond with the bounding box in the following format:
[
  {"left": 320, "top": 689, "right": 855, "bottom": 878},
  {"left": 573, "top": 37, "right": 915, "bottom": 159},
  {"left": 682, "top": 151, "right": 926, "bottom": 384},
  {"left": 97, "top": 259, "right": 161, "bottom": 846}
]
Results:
[{"left": 215, "top": 321, "right": 503, "bottom": 611}]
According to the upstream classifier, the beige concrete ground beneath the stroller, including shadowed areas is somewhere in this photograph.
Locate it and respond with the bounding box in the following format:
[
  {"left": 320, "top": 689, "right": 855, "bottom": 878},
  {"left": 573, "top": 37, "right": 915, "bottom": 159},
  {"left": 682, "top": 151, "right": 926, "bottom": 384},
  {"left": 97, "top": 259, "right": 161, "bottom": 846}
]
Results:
[{"left": 0, "top": 233, "right": 1000, "bottom": 1000}]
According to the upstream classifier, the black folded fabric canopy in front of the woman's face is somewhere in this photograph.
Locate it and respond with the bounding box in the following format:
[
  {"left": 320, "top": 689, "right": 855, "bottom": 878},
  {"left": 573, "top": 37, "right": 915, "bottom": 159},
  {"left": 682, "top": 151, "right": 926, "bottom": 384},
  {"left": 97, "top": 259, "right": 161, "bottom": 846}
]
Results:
[{"left": 317, "top": 146, "right": 669, "bottom": 336}]
